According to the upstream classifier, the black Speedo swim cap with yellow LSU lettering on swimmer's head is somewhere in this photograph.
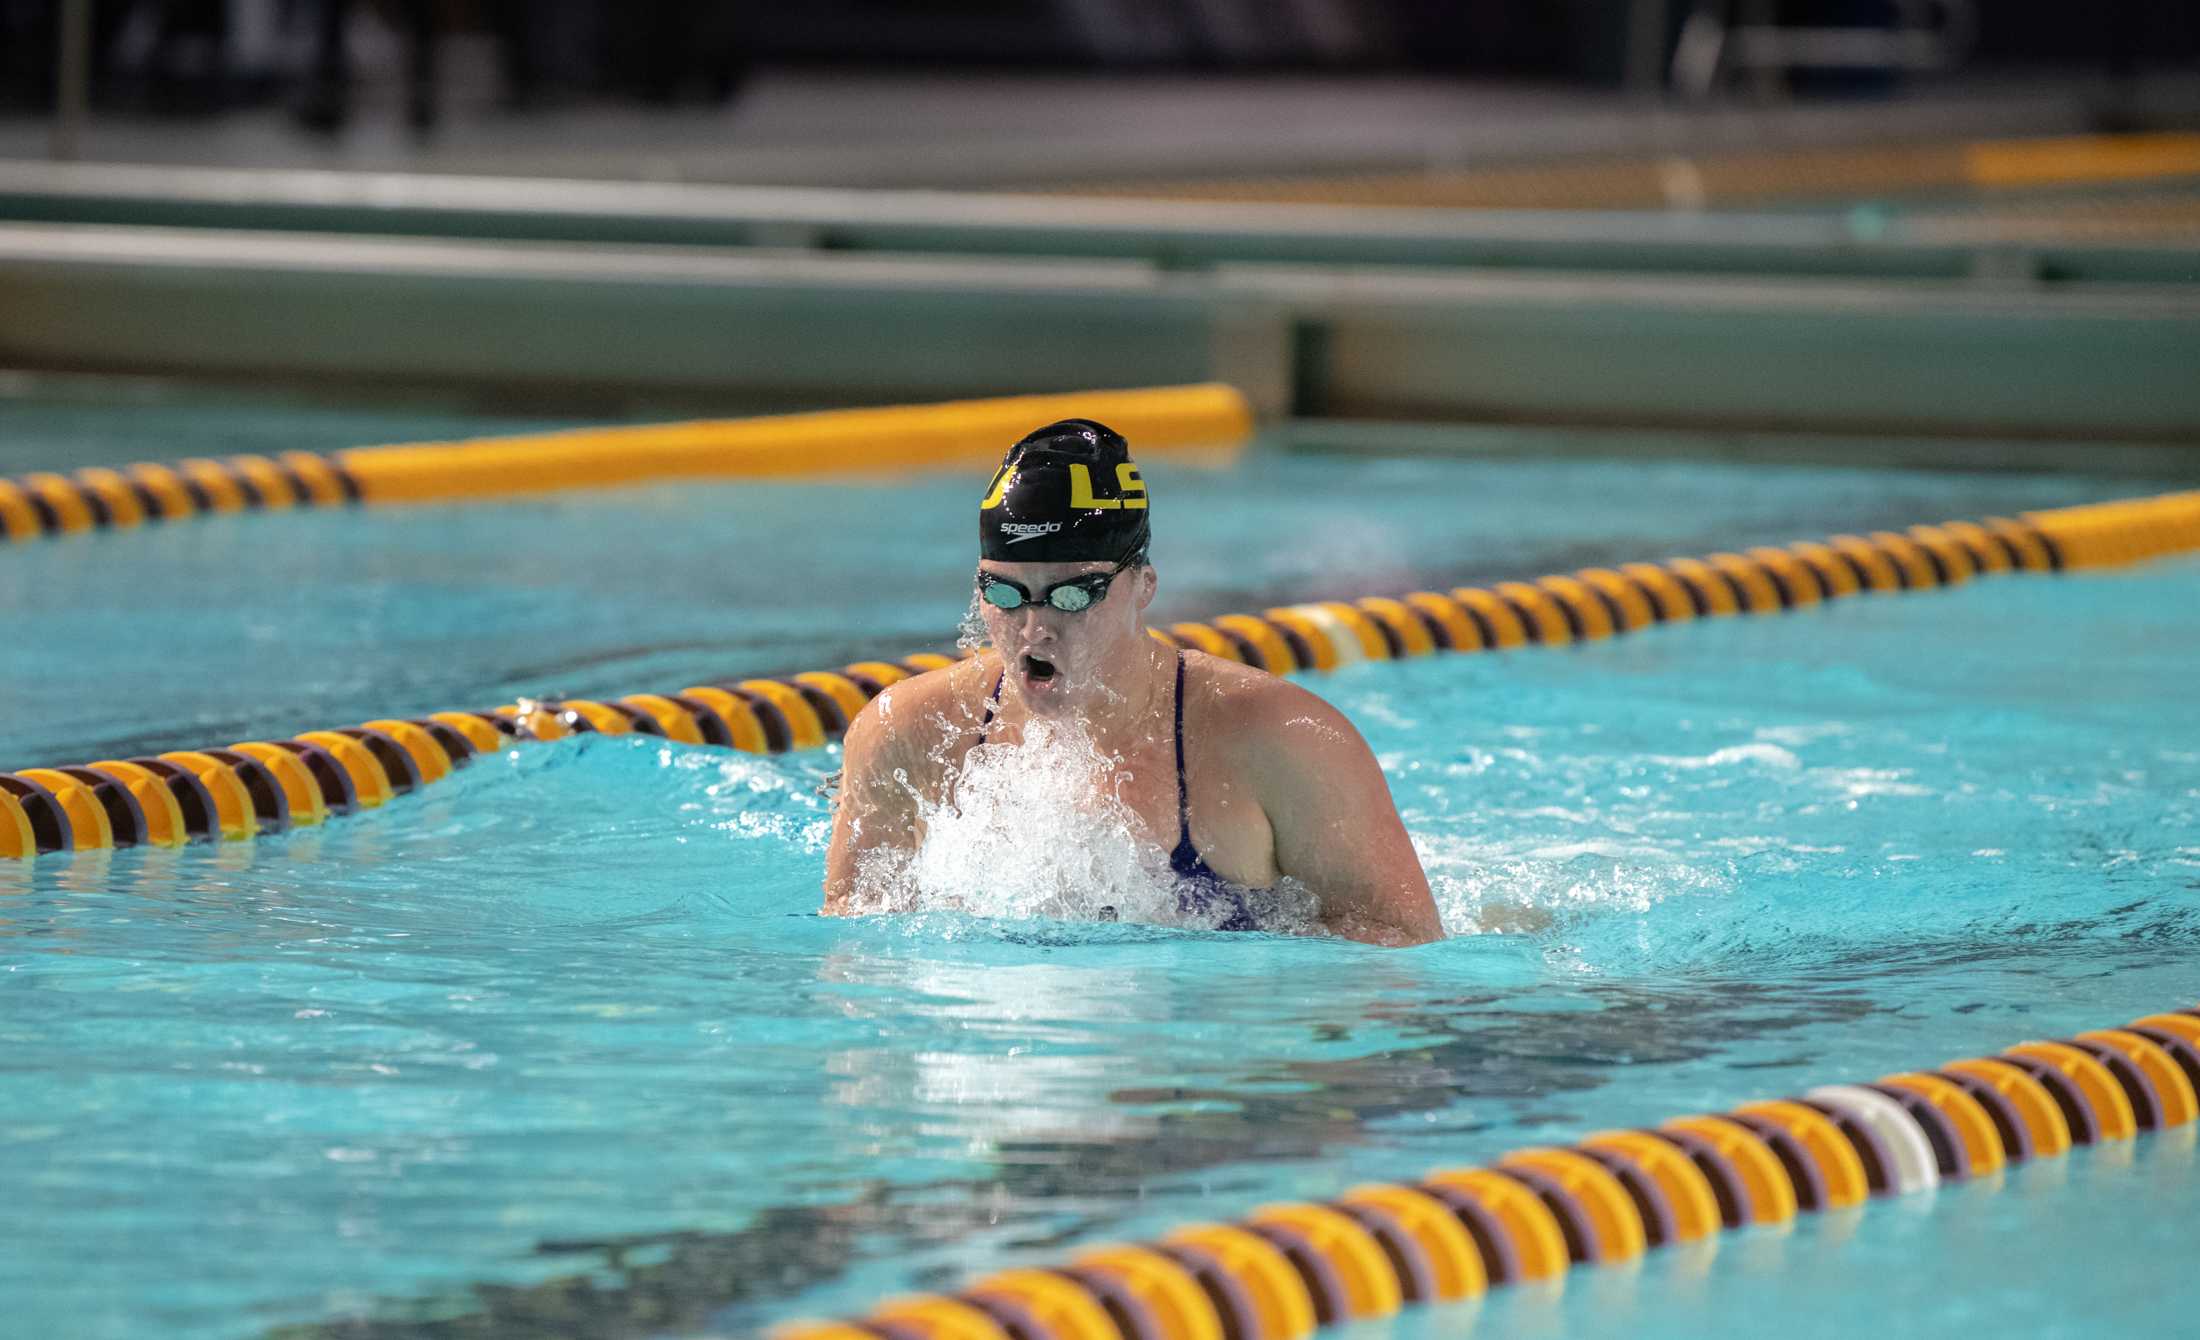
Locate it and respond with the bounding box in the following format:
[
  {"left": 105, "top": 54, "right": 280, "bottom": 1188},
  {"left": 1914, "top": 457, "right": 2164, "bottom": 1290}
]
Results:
[{"left": 977, "top": 418, "right": 1148, "bottom": 563}]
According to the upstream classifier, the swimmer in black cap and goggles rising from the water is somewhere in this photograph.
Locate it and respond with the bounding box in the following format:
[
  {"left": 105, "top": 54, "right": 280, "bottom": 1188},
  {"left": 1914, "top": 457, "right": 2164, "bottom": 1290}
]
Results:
[{"left": 825, "top": 418, "right": 1443, "bottom": 944}]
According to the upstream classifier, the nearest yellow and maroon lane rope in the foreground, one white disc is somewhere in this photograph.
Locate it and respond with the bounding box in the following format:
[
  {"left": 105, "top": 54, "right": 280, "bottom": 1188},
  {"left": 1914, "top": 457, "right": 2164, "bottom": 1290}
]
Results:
[{"left": 770, "top": 1010, "right": 2200, "bottom": 1340}]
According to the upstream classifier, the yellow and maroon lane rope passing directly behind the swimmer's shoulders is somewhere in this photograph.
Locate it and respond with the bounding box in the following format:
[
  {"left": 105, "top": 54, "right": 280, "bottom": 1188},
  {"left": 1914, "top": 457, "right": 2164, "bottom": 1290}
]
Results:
[{"left": 0, "top": 491, "right": 2200, "bottom": 858}]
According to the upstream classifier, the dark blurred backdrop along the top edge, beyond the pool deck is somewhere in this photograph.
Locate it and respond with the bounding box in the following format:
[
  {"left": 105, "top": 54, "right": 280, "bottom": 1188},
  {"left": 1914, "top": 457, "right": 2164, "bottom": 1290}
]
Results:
[{"left": 0, "top": 0, "right": 2200, "bottom": 128}]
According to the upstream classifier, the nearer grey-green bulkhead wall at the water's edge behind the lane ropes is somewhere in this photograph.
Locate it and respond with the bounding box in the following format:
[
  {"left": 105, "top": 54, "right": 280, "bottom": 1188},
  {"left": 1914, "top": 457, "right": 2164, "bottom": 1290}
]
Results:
[{"left": 0, "top": 222, "right": 2200, "bottom": 442}]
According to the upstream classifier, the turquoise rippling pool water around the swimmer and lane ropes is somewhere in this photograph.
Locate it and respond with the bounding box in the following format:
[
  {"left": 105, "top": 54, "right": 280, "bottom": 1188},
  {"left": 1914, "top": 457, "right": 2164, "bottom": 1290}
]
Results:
[{"left": 0, "top": 402, "right": 2200, "bottom": 1338}]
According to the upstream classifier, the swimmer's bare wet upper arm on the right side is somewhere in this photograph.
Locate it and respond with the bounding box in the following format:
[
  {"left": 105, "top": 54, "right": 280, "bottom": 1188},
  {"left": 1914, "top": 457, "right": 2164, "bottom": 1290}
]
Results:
[{"left": 1256, "top": 684, "right": 1443, "bottom": 946}]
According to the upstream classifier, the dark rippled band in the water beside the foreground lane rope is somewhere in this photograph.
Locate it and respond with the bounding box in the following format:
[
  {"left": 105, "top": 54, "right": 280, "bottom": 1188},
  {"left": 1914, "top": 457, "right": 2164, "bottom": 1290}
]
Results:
[{"left": 271, "top": 981, "right": 1881, "bottom": 1340}]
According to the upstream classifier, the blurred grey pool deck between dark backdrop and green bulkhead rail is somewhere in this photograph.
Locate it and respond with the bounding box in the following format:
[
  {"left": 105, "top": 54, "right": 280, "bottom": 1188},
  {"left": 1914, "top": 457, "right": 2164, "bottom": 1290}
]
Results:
[{"left": 0, "top": 64, "right": 2200, "bottom": 189}]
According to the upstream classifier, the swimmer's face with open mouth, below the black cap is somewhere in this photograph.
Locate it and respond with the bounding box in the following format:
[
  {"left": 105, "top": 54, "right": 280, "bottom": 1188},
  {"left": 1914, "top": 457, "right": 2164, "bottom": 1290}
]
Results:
[{"left": 977, "top": 559, "right": 1157, "bottom": 715}]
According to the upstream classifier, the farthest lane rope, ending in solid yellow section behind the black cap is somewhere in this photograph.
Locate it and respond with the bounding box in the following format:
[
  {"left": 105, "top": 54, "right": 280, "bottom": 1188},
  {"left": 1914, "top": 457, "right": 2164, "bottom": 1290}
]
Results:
[{"left": 0, "top": 383, "right": 1254, "bottom": 543}]
